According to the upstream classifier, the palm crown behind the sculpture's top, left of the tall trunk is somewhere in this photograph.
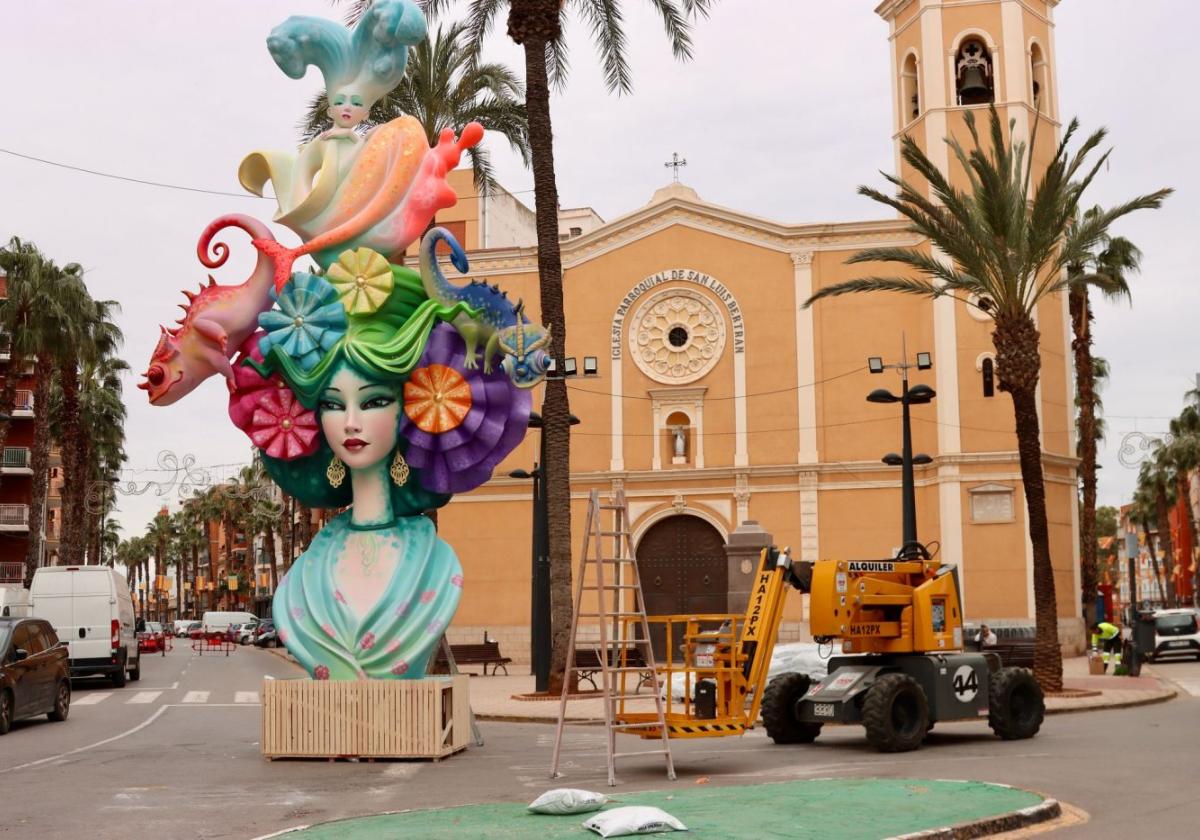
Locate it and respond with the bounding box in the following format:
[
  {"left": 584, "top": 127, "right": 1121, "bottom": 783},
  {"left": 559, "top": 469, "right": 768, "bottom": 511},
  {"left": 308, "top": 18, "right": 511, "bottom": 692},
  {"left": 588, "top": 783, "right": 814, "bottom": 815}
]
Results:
[{"left": 304, "top": 23, "right": 529, "bottom": 194}]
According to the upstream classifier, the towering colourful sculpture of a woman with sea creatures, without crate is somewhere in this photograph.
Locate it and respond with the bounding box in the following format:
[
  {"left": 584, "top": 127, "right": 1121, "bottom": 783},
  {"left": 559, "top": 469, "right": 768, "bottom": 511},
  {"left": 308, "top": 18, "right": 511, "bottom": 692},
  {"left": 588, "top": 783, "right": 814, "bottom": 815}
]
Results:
[{"left": 139, "top": 0, "right": 550, "bottom": 679}]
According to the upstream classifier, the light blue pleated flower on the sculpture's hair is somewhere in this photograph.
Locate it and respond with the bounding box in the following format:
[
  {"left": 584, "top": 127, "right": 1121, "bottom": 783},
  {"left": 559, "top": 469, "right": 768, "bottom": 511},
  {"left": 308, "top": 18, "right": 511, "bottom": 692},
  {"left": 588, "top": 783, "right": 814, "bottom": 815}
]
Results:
[{"left": 258, "top": 271, "right": 347, "bottom": 371}]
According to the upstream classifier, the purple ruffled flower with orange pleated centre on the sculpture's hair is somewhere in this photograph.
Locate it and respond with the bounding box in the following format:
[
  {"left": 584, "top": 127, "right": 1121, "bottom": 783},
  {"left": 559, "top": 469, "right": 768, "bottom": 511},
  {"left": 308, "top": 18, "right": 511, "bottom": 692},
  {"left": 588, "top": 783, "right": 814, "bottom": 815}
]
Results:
[{"left": 400, "top": 324, "right": 533, "bottom": 493}]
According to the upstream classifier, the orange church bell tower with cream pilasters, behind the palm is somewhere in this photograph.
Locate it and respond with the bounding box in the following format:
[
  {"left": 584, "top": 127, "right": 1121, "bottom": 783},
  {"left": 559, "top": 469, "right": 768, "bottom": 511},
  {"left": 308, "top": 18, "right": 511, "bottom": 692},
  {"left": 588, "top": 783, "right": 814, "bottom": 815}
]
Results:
[{"left": 875, "top": 0, "right": 1079, "bottom": 637}]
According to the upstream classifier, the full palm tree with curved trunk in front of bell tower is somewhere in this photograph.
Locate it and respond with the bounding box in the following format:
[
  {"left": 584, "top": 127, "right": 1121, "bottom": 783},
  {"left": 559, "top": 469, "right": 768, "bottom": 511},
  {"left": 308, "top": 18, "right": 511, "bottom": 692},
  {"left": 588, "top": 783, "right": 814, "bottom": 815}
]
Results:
[{"left": 805, "top": 107, "right": 1170, "bottom": 691}]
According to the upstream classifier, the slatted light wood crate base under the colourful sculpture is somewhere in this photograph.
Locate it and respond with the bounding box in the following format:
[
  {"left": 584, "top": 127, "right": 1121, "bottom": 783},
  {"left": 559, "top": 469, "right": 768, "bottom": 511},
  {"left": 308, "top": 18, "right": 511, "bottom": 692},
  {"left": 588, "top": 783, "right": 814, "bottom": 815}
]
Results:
[{"left": 262, "top": 674, "right": 470, "bottom": 758}]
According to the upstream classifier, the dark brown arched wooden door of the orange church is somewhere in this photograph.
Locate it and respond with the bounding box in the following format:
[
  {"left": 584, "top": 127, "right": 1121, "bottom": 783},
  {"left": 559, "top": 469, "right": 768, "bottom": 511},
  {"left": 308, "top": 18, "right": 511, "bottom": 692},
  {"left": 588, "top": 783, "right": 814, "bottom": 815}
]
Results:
[{"left": 637, "top": 514, "right": 730, "bottom": 661}]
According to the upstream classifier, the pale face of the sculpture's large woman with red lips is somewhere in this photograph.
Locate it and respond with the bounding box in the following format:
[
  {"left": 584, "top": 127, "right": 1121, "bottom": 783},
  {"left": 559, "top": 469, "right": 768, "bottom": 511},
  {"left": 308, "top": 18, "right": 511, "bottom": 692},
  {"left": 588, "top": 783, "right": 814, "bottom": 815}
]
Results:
[{"left": 320, "top": 365, "right": 400, "bottom": 469}]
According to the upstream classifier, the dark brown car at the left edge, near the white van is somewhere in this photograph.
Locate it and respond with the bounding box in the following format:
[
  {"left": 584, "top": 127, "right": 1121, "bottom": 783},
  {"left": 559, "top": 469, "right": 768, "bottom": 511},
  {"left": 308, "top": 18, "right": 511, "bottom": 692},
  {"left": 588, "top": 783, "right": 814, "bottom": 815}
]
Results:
[{"left": 0, "top": 617, "right": 71, "bottom": 736}]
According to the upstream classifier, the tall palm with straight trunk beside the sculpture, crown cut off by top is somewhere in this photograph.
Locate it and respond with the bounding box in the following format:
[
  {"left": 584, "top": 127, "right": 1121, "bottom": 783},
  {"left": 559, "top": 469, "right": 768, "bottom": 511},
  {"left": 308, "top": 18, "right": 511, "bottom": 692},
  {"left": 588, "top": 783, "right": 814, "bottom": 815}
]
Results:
[{"left": 393, "top": 0, "right": 713, "bottom": 692}]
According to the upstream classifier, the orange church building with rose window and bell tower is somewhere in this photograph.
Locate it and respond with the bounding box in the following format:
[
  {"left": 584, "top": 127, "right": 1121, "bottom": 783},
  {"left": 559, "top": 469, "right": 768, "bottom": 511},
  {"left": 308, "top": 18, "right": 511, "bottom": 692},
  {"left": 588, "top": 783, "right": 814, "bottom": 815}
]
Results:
[{"left": 439, "top": 0, "right": 1084, "bottom": 662}]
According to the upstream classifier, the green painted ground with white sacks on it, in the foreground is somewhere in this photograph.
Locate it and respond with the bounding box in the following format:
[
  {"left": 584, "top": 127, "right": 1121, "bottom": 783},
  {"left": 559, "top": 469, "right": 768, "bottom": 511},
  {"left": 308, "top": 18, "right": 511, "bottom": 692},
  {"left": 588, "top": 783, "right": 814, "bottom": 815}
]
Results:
[{"left": 287, "top": 779, "right": 1042, "bottom": 840}]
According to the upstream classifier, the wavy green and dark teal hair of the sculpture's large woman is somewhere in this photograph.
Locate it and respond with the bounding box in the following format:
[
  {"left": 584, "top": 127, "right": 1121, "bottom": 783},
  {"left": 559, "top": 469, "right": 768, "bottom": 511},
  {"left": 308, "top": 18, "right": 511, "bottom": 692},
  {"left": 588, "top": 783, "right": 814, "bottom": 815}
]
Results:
[{"left": 253, "top": 265, "right": 468, "bottom": 516}]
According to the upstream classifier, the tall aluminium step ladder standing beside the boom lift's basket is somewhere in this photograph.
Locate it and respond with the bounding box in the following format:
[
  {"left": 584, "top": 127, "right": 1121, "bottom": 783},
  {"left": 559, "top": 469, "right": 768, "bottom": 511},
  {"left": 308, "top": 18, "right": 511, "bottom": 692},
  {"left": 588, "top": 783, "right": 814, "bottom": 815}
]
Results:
[{"left": 550, "top": 490, "right": 676, "bottom": 785}]
